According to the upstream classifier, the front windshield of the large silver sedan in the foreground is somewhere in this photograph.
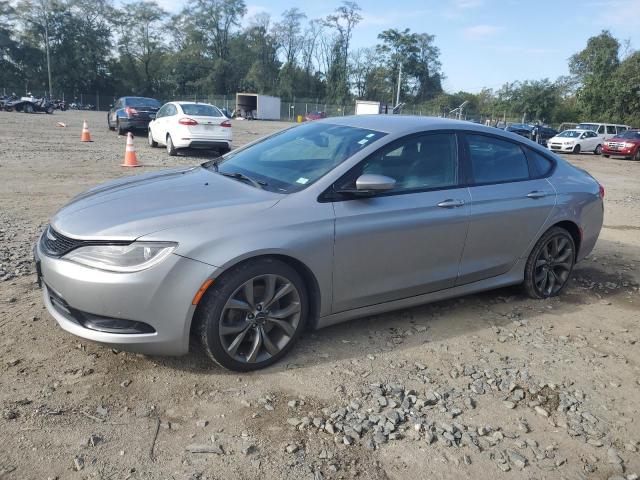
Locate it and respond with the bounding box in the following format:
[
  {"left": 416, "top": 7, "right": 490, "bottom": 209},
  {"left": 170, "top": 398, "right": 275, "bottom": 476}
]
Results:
[{"left": 210, "top": 122, "right": 385, "bottom": 193}]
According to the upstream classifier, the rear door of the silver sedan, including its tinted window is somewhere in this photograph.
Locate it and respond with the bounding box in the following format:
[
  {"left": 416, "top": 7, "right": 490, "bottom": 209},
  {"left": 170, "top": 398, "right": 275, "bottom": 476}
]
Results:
[{"left": 456, "top": 133, "right": 556, "bottom": 285}]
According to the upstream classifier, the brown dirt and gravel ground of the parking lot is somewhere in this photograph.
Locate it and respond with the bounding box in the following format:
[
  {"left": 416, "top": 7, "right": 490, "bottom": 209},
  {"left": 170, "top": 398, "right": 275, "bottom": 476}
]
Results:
[{"left": 0, "top": 112, "right": 640, "bottom": 480}]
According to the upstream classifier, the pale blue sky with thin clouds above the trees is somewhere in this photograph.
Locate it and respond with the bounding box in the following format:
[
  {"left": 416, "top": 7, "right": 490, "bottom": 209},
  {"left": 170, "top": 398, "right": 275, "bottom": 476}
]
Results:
[{"left": 159, "top": 0, "right": 640, "bottom": 92}]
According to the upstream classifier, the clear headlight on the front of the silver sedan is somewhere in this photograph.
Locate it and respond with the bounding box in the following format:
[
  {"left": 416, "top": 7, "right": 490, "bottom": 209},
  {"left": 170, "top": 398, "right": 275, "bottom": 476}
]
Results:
[{"left": 63, "top": 242, "right": 178, "bottom": 273}]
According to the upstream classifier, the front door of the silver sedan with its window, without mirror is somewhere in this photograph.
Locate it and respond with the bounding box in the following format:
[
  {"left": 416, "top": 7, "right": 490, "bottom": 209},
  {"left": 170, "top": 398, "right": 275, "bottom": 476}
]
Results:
[{"left": 333, "top": 133, "right": 470, "bottom": 313}]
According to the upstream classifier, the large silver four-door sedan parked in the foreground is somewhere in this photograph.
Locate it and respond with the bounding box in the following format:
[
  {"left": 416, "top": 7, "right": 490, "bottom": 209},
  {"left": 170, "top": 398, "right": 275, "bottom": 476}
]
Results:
[{"left": 35, "top": 115, "right": 604, "bottom": 371}]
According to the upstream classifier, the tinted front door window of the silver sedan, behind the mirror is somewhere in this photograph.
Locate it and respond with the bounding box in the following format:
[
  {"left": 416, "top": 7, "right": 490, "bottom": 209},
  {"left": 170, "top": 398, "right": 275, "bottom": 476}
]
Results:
[{"left": 352, "top": 133, "right": 458, "bottom": 192}]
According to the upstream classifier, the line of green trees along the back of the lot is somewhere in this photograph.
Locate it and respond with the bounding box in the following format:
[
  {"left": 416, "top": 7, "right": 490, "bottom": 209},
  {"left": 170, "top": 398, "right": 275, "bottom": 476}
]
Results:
[{"left": 0, "top": 0, "right": 640, "bottom": 125}]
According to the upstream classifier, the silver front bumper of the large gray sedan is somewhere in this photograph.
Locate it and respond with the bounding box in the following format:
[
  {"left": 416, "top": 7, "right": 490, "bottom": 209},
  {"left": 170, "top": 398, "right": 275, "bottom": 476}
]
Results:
[{"left": 34, "top": 245, "right": 214, "bottom": 355}]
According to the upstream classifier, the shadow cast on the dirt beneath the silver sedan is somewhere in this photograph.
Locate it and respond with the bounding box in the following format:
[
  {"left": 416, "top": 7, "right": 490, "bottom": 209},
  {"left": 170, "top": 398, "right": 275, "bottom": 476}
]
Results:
[{"left": 154, "top": 236, "right": 640, "bottom": 375}]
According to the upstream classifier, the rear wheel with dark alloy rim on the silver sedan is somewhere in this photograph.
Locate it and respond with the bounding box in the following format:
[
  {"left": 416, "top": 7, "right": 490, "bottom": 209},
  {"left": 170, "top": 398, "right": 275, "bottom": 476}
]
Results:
[{"left": 524, "top": 227, "right": 576, "bottom": 298}]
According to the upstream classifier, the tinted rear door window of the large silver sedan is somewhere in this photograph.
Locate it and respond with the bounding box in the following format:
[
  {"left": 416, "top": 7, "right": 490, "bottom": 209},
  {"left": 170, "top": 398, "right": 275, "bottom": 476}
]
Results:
[{"left": 467, "top": 135, "right": 529, "bottom": 183}]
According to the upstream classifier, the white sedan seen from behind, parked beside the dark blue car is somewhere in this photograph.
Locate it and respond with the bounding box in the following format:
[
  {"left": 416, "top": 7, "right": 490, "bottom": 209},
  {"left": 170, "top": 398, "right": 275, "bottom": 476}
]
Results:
[{"left": 149, "top": 102, "right": 233, "bottom": 156}]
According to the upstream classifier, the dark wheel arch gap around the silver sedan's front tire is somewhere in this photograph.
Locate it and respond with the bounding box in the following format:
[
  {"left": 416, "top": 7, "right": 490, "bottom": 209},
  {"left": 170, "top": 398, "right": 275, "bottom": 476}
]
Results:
[{"left": 190, "top": 253, "right": 321, "bottom": 334}]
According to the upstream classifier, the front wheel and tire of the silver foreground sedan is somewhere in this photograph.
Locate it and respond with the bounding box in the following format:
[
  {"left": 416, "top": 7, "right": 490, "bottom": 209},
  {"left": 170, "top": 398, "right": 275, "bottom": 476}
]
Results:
[{"left": 197, "top": 258, "right": 308, "bottom": 372}]
